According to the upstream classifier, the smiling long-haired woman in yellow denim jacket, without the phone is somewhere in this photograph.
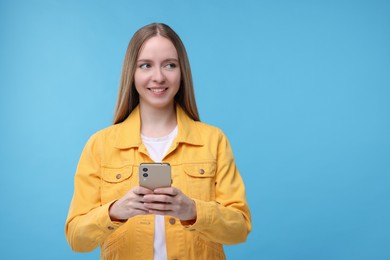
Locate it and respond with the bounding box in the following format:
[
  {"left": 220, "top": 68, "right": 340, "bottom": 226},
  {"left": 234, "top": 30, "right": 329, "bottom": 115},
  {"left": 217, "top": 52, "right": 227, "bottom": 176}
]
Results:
[{"left": 66, "top": 23, "right": 251, "bottom": 259}]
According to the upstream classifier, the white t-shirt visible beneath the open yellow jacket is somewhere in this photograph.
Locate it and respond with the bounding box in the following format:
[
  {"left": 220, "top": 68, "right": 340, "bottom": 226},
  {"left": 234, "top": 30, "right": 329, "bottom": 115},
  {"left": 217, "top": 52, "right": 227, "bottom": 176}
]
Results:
[{"left": 141, "top": 126, "right": 177, "bottom": 260}]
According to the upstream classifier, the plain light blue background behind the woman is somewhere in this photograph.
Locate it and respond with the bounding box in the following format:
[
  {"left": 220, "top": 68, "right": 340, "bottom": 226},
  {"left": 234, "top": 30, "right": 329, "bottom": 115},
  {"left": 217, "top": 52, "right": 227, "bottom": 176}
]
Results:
[{"left": 0, "top": 0, "right": 390, "bottom": 260}]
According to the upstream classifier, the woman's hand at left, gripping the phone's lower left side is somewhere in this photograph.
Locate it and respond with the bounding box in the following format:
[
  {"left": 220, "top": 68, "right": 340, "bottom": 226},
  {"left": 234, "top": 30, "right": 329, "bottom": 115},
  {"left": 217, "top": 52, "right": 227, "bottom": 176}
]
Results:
[{"left": 109, "top": 186, "right": 153, "bottom": 221}]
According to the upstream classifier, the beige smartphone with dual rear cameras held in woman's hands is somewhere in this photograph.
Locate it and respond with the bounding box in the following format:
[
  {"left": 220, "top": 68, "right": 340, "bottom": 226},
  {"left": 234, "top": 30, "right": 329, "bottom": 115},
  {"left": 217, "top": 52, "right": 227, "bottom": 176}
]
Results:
[{"left": 138, "top": 163, "right": 172, "bottom": 190}]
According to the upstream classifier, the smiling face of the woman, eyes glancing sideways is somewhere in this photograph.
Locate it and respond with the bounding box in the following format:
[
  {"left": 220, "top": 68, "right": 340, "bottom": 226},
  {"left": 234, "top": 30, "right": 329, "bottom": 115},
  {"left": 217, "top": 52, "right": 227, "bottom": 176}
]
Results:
[{"left": 134, "top": 36, "right": 180, "bottom": 108}]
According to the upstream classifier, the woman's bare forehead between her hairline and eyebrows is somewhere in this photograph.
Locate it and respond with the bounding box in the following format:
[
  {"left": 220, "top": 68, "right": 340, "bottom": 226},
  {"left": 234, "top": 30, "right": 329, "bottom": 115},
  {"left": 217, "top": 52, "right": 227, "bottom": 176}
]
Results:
[{"left": 138, "top": 35, "right": 178, "bottom": 59}]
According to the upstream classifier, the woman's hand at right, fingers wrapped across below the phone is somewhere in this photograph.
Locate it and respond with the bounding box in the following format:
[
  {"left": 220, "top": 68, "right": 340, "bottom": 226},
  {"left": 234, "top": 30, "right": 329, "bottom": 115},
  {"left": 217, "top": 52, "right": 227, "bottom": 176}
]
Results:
[{"left": 143, "top": 187, "right": 196, "bottom": 221}]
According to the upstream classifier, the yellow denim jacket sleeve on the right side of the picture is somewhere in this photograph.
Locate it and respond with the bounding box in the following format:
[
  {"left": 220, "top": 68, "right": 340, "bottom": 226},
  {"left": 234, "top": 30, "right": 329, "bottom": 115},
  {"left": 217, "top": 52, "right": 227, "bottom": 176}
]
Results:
[{"left": 182, "top": 132, "right": 252, "bottom": 244}]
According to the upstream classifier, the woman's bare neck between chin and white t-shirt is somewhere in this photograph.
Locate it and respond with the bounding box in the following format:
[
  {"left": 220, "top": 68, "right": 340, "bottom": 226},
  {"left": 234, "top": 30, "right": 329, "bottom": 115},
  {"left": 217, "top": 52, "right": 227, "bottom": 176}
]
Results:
[{"left": 140, "top": 103, "right": 177, "bottom": 137}]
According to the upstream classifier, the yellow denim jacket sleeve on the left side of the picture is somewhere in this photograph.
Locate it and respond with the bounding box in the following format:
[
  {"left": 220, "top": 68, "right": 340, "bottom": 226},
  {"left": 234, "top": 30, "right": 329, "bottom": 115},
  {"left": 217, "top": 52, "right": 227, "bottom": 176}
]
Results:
[{"left": 65, "top": 135, "right": 121, "bottom": 252}]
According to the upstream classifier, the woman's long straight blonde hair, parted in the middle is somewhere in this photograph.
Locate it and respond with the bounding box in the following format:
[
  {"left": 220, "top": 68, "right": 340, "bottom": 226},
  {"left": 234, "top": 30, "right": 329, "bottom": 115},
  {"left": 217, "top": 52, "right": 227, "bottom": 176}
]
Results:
[{"left": 114, "top": 23, "right": 200, "bottom": 124}]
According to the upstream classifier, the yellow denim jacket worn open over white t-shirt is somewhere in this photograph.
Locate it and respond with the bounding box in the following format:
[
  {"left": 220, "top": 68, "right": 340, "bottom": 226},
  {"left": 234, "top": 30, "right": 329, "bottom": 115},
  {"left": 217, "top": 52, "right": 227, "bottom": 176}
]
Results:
[{"left": 65, "top": 106, "right": 251, "bottom": 260}]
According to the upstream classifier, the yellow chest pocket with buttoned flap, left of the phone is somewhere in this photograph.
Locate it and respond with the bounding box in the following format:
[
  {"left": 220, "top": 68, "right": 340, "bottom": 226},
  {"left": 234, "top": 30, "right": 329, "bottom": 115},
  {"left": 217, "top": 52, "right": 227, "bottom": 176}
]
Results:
[{"left": 101, "top": 166, "right": 134, "bottom": 204}]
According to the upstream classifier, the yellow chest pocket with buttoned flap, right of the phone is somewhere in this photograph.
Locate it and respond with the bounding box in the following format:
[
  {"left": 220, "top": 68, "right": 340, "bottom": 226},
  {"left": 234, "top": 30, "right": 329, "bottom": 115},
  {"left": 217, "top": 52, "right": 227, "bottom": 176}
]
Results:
[{"left": 184, "top": 163, "right": 216, "bottom": 201}]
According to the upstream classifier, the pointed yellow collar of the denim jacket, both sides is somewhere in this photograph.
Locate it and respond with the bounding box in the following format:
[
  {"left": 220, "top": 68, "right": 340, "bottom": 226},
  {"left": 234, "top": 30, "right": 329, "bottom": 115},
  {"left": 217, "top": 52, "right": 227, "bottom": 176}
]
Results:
[{"left": 115, "top": 105, "right": 203, "bottom": 149}]
